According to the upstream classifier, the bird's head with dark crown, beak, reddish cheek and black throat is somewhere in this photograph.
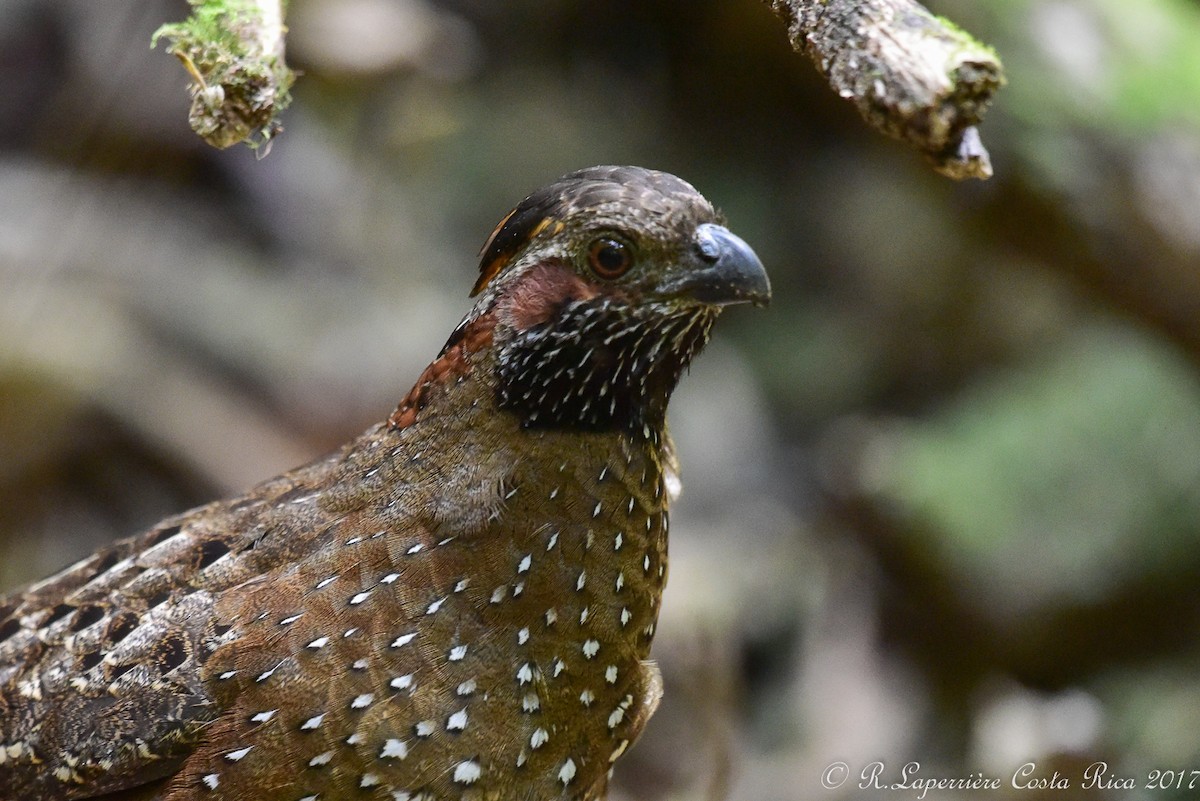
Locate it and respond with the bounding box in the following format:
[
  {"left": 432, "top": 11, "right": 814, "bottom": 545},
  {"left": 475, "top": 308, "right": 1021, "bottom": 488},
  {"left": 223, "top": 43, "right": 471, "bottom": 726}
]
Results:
[{"left": 460, "top": 167, "right": 770, "bottom": 430}]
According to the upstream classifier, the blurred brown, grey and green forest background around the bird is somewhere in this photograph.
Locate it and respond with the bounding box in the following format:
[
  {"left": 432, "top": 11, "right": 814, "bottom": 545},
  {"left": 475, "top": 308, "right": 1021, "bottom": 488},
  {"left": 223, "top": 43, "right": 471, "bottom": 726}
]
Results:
[{"left": 0, "top": 0, "right": 1200, "bottom": 801}]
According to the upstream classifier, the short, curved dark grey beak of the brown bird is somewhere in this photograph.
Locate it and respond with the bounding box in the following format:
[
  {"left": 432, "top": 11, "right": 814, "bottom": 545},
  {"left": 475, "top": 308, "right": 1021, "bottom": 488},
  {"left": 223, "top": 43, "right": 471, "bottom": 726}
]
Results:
[{"left": 660, "top": 223, "right": 770, "bottom": 306}]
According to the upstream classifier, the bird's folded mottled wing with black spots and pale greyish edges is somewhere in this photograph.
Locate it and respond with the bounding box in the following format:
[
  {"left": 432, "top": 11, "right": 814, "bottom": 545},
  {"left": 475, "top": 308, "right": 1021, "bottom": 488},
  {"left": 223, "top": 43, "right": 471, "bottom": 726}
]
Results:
[{"left": 0, "top": 453, "right": 352, "bottom": 801}]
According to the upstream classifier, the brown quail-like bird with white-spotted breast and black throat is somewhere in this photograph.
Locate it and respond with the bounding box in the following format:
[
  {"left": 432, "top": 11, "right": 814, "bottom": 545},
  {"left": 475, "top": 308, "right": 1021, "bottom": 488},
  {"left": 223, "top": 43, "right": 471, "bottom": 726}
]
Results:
[{"left": 0, "top": 167, "right": 770, "bottom": 801}]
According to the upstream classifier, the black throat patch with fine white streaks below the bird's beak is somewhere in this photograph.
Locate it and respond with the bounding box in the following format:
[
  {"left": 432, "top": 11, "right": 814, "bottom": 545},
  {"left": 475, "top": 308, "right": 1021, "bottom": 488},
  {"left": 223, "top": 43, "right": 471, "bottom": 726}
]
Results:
[{"left": 497, "top": 297, "right": 716, "bottom": 432}]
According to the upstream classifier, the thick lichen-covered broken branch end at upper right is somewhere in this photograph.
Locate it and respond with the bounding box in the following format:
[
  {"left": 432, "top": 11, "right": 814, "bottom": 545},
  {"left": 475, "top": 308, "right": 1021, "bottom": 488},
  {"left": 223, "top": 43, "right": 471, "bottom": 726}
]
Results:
[{"left": 764, "top": 0, "right": 1004, "bottom": 179}]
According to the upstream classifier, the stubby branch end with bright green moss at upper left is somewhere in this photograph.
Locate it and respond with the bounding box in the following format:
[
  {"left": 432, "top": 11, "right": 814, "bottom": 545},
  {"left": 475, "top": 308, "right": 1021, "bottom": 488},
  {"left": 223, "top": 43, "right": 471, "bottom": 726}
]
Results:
[{"left": 150, "top": 0, "right": 293, "bottom": 147}]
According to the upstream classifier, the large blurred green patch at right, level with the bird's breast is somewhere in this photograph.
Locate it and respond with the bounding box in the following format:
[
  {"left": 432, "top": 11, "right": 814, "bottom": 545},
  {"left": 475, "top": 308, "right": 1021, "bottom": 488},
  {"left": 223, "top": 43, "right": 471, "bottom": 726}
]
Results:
[{"left": 877, "top": 326, "right": 1200, "bottom": 614}]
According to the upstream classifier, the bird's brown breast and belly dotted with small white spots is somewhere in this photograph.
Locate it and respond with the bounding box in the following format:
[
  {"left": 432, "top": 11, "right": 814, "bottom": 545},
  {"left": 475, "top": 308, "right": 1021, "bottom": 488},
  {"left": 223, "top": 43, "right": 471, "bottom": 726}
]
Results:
[{"left": 185, "top": 436, "right": 667, "bottom": 799}]
